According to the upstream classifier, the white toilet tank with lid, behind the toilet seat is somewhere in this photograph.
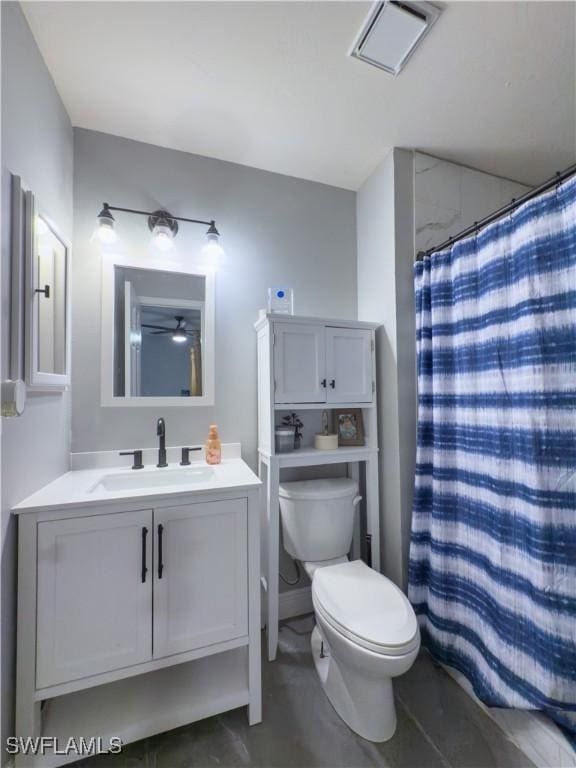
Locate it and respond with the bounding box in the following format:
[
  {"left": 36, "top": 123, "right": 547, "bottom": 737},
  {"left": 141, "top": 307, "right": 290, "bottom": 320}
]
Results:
[{"left": 280, "top": 477, "right": 361, "bottom": 562}]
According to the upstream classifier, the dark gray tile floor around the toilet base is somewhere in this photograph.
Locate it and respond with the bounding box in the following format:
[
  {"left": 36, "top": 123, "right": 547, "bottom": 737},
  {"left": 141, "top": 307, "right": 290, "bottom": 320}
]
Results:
[{"left": 75, "top": 616, "right": 533, "bottom": 768}]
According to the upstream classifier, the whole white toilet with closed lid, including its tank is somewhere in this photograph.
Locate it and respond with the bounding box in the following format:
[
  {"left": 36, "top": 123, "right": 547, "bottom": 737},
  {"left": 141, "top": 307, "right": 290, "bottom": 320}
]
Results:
[{"left": 280, "top": 477, "right": 420, "bottom": 742}]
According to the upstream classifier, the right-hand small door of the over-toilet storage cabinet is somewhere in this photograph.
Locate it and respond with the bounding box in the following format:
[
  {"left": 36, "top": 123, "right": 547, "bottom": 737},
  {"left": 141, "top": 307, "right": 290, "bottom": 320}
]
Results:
[{"left": 326, "top": 328, "right": 373, "bottom": 403}]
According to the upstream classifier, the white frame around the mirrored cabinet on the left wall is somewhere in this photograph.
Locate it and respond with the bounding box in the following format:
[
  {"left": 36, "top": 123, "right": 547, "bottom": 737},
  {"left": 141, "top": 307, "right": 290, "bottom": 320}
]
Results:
[{"left": 24, "top": 190, "right": 72, "bottom": 392}]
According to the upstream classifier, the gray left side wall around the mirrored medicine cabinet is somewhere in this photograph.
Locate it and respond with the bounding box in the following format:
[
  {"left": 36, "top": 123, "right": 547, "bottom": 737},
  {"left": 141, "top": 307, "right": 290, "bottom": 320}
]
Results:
[{"left": 1, "top": 2, "right": 73, "bottom": 760}]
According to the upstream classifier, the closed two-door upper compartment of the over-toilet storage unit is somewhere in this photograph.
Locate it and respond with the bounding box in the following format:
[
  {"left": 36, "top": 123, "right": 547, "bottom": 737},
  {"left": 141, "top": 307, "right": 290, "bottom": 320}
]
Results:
[{"left": 273, "top": 321, "right": 375, "bottom": 404}]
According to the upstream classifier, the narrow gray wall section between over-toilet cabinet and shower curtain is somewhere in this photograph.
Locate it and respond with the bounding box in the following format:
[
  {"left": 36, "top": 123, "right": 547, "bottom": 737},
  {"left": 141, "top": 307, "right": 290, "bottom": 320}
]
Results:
[{"left": 356, "top": 149, "right": 416, "bottom": 587}]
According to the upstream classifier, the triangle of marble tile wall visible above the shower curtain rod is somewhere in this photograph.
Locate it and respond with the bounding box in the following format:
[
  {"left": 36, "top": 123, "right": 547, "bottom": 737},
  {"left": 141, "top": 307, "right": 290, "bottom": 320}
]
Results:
[{"left": 414, "top": 152, "right": 529, "bottom": 251}]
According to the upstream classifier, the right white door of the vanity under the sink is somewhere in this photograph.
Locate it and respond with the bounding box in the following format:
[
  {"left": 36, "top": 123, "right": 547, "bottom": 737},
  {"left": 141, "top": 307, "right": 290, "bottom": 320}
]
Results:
[{"left": 154, "top": 499, "right": 248, "bottom": 658}]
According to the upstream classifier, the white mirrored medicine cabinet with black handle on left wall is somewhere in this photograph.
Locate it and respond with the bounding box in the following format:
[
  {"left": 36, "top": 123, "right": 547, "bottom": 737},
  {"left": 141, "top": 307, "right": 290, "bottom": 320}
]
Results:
[{"left": 25, "top": 192, "right": 70, "bottom": 390}]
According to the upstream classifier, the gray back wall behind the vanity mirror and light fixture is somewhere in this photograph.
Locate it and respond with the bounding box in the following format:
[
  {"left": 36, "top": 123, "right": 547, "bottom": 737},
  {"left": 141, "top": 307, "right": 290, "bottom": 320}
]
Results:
[{"left": 72, "top": 129, "right": 356, "bottom": 467}]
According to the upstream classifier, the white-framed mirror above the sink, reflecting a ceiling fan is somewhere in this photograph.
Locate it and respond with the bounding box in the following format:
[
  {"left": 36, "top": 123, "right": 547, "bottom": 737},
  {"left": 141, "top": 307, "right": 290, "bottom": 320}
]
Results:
[{"left": 101, "top": 256, "right": 214, "bottom": 407}]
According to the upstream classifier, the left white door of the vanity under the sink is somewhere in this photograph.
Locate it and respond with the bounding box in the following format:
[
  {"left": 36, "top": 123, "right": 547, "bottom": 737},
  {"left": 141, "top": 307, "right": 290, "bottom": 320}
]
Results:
[{"left": 36, "top": 510, "right": 152, "bottom": 688}]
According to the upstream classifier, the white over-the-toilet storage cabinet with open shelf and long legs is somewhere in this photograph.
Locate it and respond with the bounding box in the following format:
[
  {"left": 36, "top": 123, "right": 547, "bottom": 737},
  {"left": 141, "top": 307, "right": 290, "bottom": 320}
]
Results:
[{"left": 255, "top": 313, "right": 380, "bottom": 659}]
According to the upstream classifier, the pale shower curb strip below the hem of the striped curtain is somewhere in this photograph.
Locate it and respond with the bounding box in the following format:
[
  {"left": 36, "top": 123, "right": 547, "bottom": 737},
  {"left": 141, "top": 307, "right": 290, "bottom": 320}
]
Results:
[{"left": 442, "top": 664, "right": 576, "bottom": 768}]
